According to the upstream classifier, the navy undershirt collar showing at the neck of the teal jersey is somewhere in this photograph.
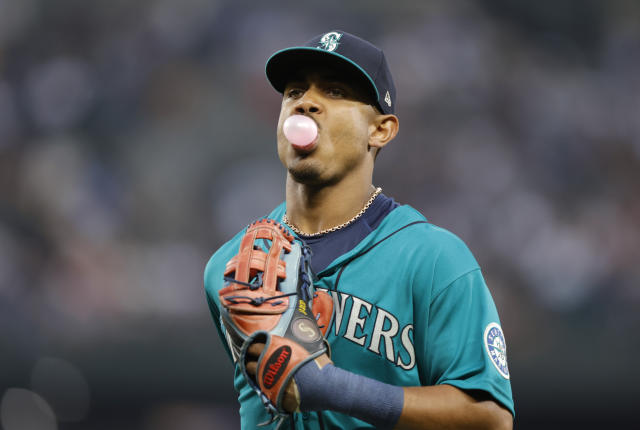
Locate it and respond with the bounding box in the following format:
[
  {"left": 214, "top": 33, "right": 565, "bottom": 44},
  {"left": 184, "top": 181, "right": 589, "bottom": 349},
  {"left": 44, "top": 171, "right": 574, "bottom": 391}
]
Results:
[{"left": 300, "top": 194, "right": 400, "bottom": 273}]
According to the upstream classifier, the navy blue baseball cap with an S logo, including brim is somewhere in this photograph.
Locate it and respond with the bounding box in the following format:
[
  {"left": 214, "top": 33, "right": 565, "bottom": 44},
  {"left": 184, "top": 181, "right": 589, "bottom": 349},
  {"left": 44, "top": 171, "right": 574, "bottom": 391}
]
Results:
[{"left": 266, "top": 30, "right": 396, "bottom": 114}]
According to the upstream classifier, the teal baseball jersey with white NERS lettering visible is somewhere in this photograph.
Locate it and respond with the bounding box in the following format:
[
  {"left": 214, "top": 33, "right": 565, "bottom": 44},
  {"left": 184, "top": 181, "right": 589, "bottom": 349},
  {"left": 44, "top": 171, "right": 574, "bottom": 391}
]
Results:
[{"left": 204, "top": 203, "right": 514, "bottom": 429}]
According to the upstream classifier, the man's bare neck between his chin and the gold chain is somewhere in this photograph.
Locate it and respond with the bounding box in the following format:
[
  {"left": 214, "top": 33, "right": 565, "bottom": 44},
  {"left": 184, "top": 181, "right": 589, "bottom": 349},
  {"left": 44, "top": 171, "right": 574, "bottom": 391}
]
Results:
[{"left": 286, "top": 175, "right": 375, "bottom": 234}]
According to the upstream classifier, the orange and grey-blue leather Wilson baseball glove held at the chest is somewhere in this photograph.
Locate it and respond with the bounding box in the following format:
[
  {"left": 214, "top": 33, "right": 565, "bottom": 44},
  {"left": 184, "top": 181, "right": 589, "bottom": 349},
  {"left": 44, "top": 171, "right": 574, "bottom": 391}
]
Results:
[{"left": 219, "top": 219, "right": 333, "bottom": 421}]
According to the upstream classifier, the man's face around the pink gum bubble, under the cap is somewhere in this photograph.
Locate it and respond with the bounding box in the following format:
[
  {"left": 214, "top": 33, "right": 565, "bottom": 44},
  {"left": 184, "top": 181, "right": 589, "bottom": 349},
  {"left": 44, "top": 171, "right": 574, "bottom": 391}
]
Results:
[{"left": 277, "top": 67, "right": 377, "bottom": 185}]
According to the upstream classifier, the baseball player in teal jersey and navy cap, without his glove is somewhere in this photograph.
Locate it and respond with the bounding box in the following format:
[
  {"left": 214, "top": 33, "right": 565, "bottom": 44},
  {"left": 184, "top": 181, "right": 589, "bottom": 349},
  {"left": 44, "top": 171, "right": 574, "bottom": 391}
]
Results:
[{"left": 204, "top": 31, "right": 514, "bottom": 430}]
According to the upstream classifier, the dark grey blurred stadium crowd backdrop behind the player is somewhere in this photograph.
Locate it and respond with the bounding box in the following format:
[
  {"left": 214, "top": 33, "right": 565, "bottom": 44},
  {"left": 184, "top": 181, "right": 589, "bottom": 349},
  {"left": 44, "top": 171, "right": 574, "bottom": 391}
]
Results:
[{"left": 0, "top": 0, "right": 640, "bottom": 430}]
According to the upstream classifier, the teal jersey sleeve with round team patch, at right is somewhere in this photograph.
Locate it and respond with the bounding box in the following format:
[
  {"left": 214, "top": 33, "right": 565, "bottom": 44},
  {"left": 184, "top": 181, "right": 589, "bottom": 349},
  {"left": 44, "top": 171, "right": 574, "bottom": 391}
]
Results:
[{"left": 426, "top": 269, "right": 515, "bottom": 415}]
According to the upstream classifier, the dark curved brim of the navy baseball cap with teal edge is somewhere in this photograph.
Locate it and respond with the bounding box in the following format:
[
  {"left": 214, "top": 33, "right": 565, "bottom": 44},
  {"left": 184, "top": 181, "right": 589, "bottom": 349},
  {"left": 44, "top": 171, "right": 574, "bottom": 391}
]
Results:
[{"left": 266, "top": 46, "right": 380, "bottom": 104}]
